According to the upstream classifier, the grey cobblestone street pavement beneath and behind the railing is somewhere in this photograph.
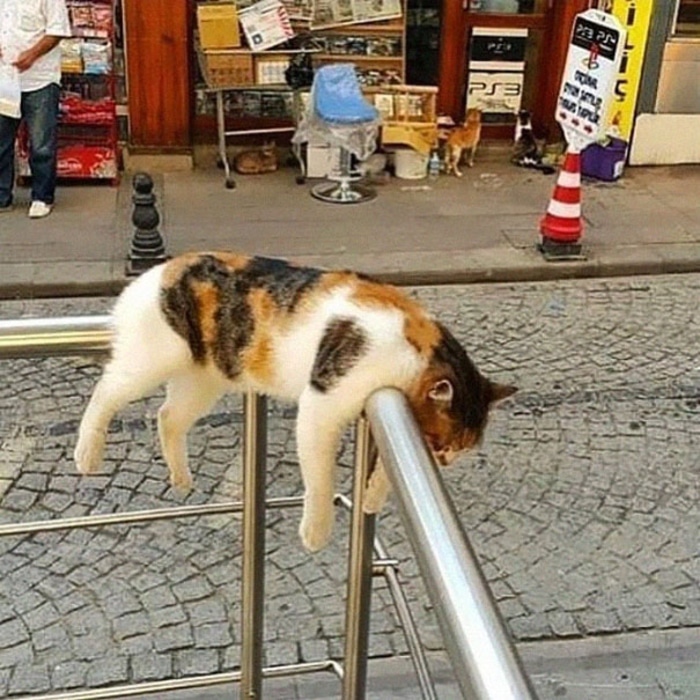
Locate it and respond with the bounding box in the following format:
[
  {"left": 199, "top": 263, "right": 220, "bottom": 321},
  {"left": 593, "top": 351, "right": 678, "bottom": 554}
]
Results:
[{"left": 0, "top": 275, "right": 700, "bottom": 695}]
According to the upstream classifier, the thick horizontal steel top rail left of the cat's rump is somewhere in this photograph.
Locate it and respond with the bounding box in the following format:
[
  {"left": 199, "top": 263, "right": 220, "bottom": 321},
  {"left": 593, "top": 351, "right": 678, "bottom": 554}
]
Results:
[{"left": 0, "top": 315, "right": 112, "bottom": 360}]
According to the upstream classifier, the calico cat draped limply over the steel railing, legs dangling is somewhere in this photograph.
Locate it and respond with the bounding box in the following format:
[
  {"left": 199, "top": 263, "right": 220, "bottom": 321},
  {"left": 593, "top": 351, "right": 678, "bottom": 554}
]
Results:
[{"left": 75, "top": 253, "right": 515, "bottom": 551}]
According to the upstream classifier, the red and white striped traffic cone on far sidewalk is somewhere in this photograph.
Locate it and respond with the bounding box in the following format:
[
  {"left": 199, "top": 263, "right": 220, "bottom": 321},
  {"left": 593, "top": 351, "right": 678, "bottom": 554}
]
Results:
[{"left": 540, "top": 148, "right": 583, "bottom": 256}]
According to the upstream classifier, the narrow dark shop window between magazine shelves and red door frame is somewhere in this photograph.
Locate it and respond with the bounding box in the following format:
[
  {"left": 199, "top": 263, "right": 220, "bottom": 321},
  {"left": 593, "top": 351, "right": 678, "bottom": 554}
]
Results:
[{"left": 406, "top": 0, "right": 442, "bottom": 85}]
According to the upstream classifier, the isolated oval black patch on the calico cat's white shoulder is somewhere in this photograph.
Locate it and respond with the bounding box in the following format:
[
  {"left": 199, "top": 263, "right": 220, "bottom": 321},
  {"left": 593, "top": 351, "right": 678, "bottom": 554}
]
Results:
[{"left": 311, "top": 318, "right": 368, "bottom": 392}]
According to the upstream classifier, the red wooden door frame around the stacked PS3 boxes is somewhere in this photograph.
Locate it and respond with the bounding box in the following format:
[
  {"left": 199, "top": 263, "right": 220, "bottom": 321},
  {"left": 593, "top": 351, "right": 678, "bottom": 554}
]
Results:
[{"left": 438, "top": 0, "right": 590, "bottom": 137}]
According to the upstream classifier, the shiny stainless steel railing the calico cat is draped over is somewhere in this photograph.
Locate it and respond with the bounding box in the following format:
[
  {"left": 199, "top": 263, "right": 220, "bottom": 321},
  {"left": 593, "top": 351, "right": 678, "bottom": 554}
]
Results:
[{"left": 0, "top": 316, "right": 535, "bottom": 700}]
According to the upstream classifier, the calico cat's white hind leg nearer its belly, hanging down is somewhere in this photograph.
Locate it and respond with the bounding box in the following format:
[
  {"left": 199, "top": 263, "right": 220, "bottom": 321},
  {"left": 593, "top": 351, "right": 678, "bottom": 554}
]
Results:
[{"left": 158, "top": 367, "right": 224, "bottom": 492}]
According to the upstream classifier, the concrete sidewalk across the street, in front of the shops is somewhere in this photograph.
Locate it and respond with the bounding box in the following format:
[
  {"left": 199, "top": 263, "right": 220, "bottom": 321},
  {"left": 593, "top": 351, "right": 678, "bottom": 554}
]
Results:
[{"left": 0, "top": 152, "right": 700, "bottom": 298}]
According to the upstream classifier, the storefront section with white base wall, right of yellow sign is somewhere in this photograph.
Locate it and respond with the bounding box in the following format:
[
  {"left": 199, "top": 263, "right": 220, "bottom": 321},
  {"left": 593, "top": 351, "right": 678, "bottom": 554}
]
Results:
[{"left": 630, "top": 0, "right": 700, "bottom": 165}]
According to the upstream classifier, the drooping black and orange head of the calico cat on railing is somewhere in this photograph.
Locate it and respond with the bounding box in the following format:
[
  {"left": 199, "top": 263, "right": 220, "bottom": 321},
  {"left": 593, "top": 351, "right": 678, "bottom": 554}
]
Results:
[{"left": 408, "top": 326, "right": 517, "bottom": 466}]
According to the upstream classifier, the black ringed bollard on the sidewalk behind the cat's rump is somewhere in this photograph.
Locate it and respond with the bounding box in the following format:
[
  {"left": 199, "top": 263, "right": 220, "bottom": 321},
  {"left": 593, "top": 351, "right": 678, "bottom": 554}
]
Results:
[{"left": 126, "top": 173, "right": 167, "bottom": 275}]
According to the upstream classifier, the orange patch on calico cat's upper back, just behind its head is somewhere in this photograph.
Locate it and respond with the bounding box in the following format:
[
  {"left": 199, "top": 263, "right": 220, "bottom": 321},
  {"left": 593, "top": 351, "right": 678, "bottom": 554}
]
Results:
[{"left": 352, "top": 280, "right": 440, "bottom": 356}]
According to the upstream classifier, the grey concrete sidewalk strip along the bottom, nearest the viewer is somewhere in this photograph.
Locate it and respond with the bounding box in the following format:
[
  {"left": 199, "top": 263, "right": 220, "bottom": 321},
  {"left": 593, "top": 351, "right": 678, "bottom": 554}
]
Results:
[{"left": 127, "top": 629, "right": 700, "bottom": 700}]
